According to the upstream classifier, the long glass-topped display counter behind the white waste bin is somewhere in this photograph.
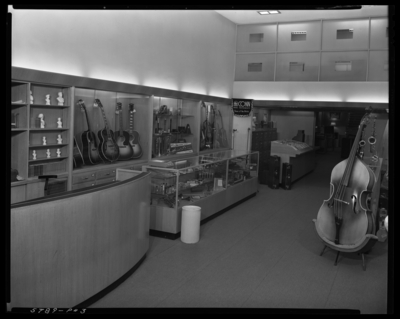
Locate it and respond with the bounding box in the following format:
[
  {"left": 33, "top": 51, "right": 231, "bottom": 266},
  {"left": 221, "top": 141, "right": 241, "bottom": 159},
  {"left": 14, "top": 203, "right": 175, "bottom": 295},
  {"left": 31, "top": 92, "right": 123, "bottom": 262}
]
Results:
[{"left": 142, "top": 150, "right": 258, "bottom": 239}]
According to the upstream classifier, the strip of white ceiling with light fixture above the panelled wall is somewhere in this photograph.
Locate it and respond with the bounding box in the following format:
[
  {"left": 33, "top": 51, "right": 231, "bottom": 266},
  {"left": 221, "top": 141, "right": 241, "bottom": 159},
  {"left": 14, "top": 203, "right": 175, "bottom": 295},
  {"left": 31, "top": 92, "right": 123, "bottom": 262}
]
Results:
[{"left": 215, "top": 5, "right": 388, "bottom": 24}]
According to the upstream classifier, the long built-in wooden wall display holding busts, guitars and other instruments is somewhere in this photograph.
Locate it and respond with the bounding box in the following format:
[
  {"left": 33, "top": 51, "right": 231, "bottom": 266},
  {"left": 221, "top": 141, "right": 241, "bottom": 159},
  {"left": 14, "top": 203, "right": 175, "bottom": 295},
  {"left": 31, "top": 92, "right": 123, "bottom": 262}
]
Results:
[{"left": 10, "top": 68, "right": 233, "bottom": 203}]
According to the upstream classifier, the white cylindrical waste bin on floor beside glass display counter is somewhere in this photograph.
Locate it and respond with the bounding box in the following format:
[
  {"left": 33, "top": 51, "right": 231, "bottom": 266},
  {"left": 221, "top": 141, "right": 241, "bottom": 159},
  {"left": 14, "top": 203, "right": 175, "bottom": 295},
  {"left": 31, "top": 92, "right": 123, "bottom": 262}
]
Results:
[{"left": 181, "top": 206, "right": 201, "bottom": 244}]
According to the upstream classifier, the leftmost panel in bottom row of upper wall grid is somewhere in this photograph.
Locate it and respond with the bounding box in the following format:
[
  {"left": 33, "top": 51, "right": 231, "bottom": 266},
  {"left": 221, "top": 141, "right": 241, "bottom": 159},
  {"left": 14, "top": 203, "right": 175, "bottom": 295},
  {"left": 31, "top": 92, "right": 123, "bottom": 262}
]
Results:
[{"left": 235, "top": 53, "right": 275, "bottom": 81}]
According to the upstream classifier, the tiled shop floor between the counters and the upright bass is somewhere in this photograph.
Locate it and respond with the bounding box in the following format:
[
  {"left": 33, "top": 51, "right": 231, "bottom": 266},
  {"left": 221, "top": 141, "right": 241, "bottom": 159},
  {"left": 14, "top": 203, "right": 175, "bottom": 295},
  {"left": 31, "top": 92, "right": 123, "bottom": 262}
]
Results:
[{"left": 90, "top": 152, "right": 387, "bottom": 314}]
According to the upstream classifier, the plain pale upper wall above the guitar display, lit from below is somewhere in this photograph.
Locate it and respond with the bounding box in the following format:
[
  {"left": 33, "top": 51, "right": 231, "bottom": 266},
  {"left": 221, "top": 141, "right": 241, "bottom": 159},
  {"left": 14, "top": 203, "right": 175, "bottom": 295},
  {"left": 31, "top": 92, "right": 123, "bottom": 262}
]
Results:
[{"left": 9, "top": 6, "right": 236, "bottom": 98}]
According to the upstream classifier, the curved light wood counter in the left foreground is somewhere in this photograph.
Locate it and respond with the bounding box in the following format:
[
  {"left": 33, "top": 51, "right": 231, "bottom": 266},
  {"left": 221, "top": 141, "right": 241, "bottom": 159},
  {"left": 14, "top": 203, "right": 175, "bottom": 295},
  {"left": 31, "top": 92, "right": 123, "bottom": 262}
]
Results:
[{"left": 10, "top": 169, "right": 150, "bottom": 308}]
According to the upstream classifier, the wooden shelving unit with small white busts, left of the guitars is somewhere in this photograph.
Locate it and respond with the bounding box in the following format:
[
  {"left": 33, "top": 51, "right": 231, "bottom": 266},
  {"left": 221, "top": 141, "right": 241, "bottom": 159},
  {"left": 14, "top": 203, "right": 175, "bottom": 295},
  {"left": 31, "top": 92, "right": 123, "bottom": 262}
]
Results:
[{"left": 11, "top": 81, "right": 71, "bottom": 203}]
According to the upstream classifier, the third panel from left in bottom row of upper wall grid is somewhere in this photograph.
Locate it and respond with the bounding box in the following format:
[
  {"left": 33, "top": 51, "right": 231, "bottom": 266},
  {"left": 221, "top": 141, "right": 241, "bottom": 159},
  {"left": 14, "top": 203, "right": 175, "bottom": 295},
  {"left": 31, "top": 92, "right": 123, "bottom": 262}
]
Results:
[{"left": 320, "top": 51, "right": 367, "bottom": 81}]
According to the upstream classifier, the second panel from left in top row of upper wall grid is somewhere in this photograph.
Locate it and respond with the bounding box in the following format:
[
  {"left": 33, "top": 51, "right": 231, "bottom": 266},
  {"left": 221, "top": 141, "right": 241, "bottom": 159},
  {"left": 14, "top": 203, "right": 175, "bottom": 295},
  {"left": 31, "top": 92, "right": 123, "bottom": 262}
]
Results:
[{"left": 278, "top": 21, "right": 321, "bottom": 52}]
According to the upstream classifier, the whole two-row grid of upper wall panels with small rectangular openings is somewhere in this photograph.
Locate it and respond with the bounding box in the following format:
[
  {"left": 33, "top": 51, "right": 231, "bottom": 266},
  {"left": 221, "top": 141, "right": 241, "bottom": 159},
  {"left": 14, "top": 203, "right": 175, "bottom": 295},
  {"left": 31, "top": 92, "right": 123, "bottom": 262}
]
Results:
[{"left": 235, "top": 16, "right": 388, "bottom": 81}]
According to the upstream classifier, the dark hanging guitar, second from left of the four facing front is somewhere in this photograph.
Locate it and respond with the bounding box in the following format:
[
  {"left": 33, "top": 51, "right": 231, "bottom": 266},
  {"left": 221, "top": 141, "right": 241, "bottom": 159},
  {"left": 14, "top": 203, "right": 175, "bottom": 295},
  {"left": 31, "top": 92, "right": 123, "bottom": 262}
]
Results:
[{"left": 94, "top": 99, "right": 119, "bottom": 163}]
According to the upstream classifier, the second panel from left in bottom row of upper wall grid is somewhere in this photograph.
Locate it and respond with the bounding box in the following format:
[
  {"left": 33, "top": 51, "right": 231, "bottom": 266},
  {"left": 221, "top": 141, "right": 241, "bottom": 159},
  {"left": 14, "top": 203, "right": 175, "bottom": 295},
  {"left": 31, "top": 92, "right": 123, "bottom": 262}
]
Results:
[{"left": 276, "top": 52, "right": 319, "bottom": 81}]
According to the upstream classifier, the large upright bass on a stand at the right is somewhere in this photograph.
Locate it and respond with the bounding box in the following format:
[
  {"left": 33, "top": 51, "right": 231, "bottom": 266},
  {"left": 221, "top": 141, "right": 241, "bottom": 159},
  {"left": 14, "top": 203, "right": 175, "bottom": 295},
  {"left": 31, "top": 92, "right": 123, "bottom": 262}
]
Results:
[{"left": 315, "top": 114, "right": 375, "bottom": 250}]
